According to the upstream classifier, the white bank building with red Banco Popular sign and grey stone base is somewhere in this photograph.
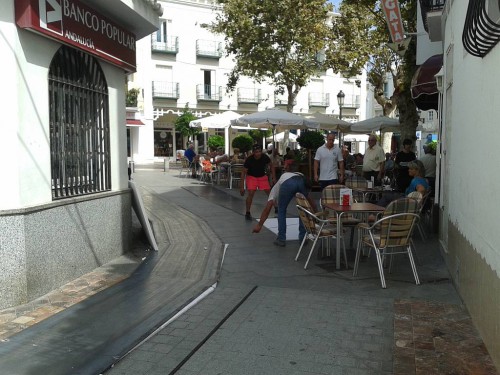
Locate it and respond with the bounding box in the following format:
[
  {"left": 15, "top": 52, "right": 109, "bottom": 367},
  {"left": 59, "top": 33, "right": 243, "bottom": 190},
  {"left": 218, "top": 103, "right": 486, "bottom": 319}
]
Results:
[{"left": 0, "top": 0, "right": 161, "bottom": 308}]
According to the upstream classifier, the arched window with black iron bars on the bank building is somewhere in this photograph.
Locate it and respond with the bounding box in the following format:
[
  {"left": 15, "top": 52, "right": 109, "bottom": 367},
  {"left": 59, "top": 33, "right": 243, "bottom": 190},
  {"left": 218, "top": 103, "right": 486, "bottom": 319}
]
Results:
[{"left": 49, "top": 46, "right": 111, "bottom": 199}]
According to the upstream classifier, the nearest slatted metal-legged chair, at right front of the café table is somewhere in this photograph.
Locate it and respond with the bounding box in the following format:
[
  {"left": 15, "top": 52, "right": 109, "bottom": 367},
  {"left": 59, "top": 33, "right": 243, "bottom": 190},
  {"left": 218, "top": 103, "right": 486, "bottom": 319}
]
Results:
[{"left": 353, "top": 197, "right": 420, "bottom": 288}]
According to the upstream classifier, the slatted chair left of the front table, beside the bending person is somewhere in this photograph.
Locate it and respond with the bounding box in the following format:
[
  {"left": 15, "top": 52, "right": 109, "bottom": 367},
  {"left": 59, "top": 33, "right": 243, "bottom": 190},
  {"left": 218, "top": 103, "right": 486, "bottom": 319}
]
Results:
[{"left": 295, "top": 193, "right": 347, "bottom": 269}]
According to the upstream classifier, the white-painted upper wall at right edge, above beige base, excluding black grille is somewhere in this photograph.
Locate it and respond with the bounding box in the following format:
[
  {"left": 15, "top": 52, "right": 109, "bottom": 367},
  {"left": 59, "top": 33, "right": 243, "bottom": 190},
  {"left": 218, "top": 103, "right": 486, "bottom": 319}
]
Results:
[{"left": 444, "top": 2, "right": 500, "bottom": 275}]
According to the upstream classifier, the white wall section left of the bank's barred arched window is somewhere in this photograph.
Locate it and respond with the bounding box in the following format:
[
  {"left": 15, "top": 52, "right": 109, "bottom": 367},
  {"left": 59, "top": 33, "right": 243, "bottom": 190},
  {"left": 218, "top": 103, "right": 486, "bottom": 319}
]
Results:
[{"left": 0, "top": 8, "right": 59, "bottom": 210}]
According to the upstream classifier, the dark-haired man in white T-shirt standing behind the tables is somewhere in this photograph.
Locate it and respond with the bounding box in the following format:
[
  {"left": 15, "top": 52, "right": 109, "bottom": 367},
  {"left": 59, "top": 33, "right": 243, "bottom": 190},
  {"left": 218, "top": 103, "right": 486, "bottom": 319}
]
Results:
[{"left": 314, "top": 133, "right": 344, "bottom": 190}]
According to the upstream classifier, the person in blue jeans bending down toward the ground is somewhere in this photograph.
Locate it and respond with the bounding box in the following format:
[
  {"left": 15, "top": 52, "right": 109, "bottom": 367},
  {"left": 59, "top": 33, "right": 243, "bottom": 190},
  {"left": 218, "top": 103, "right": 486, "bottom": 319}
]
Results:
[{"left": 252, "top": 160, "right": 316, "bottom": 247}]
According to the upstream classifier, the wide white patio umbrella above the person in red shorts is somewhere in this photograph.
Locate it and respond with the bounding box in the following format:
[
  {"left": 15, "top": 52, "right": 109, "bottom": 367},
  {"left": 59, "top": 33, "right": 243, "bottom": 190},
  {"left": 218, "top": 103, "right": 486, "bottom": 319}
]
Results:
[{"left": 231, "top": 108, "right": 319, "bottom": 148}]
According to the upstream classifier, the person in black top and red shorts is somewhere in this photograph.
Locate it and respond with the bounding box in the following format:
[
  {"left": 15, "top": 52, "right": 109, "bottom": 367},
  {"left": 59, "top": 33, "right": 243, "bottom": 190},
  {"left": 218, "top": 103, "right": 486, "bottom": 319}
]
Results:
[{"left": 240, "top": 145, "right": 276, "bottom": 220}]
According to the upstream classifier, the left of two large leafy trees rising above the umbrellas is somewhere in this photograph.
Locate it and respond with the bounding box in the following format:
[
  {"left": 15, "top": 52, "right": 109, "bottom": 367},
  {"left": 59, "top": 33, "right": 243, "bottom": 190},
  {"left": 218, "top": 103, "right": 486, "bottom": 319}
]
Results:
[{"left": 205, "top": 0, "right": 335, "bottom": 112}]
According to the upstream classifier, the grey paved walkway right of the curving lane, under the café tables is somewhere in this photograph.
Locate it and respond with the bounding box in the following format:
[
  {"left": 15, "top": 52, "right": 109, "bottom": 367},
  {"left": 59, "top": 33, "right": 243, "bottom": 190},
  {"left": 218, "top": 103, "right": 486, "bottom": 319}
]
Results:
[{"left": 106, "top": 168, "right": 496, "bottom": 375}]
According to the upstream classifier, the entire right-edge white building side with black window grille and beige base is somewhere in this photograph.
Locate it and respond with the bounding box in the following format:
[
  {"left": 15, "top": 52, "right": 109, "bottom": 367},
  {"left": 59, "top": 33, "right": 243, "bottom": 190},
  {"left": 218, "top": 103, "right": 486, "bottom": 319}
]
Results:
[{"left": 419, "top": 0, "right": 500, "bottom": 367}]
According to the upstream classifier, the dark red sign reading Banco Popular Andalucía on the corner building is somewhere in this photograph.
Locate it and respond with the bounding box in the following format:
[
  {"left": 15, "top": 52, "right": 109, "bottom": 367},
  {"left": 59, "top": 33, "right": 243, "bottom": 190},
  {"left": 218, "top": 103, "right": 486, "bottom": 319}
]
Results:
[{"left": 15, "top": 0, "right": 136, "bottom": 72}]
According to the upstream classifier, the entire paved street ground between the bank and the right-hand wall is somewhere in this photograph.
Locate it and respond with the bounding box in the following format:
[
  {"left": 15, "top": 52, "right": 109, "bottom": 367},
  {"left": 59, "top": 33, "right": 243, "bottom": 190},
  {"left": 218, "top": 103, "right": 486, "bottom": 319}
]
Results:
[{"left": 0, "top": 166, "right": 497, "bottom": 375}]
